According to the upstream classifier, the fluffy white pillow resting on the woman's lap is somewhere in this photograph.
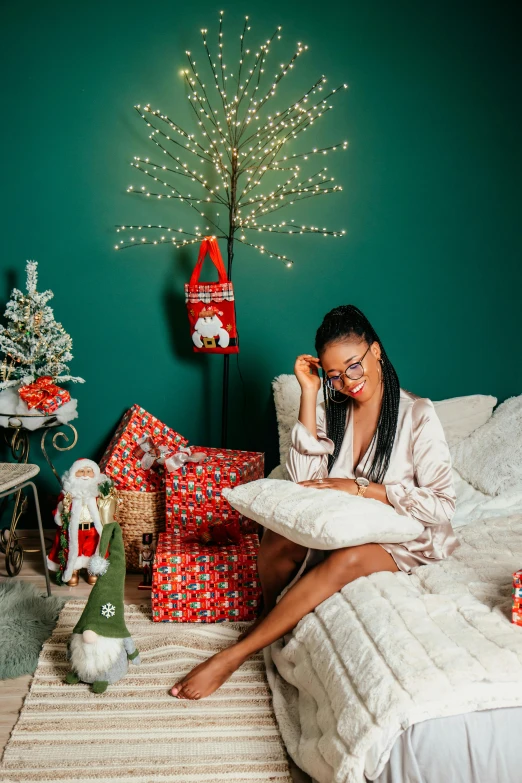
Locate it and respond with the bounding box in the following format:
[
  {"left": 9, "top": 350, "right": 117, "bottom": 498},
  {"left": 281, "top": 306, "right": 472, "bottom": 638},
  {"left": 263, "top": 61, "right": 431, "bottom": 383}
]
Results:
[{"left": 223, "top": 479, "right": 424, "bottom": 549}]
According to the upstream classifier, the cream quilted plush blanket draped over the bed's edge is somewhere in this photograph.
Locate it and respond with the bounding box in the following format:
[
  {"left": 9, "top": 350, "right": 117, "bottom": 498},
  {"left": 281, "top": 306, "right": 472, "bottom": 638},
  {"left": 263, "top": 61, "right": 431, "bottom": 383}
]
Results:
[{"left": 267, "top": 514, "right": 522, "bottom": 783}]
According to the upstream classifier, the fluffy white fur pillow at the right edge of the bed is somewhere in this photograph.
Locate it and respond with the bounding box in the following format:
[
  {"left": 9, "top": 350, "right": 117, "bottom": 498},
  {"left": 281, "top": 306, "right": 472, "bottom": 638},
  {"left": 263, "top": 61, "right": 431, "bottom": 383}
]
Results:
[{"left": 451, "top": 395, "right": 522, "bottom": 495}]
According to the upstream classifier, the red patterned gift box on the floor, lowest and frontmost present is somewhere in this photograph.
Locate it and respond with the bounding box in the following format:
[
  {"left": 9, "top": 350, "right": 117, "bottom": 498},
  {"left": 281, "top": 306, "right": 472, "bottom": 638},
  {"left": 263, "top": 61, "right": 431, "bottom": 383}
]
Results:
[{"left": 152, "top": 533, "right": 261, "bottom": 623}]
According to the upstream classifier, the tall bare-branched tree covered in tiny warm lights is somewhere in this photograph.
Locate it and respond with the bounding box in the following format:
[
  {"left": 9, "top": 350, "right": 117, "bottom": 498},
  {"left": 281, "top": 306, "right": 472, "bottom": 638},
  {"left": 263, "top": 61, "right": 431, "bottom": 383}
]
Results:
[{"left": 116, "top": 11, "right": 348, "bottom": 445}]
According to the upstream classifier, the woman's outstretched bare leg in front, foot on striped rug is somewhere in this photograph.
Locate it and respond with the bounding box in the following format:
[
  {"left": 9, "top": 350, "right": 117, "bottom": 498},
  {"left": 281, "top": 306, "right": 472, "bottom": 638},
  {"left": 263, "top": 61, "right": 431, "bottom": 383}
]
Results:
[{"left": 171, "top": 544, "right": 398, "bottom": 699}]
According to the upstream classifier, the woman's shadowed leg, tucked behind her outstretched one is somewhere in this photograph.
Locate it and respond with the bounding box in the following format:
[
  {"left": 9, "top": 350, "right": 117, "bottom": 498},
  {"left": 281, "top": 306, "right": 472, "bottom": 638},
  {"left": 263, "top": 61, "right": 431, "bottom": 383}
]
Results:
[{"left": 240, "top": 530, "right": 308, "bottom": 639}]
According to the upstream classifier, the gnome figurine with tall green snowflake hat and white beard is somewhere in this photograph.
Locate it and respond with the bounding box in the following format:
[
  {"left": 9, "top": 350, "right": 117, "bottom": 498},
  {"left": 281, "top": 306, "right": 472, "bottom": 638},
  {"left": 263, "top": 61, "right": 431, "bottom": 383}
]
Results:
[{"left": 65, "top": 522, "right": 141, "bottom": 693}]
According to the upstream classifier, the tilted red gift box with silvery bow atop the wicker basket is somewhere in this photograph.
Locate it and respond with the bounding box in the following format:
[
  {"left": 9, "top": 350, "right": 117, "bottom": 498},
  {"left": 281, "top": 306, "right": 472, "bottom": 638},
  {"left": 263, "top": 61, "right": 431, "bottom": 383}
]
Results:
[{"left": 100, "top": 405, "right": 188, "bottom": 492}]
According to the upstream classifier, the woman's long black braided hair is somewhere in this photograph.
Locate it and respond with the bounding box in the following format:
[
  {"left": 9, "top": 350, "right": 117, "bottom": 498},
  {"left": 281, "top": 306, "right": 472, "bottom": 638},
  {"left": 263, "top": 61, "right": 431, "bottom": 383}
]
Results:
[{"left": 315, "top": 305, "right": 400, "bottom": 484}]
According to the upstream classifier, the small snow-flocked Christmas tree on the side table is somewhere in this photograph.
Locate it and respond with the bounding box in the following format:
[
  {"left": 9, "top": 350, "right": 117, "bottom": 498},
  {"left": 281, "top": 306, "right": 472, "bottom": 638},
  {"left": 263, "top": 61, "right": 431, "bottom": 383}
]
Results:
[{"left": 0, "top": 261, "right": 84, "bottom": 389}]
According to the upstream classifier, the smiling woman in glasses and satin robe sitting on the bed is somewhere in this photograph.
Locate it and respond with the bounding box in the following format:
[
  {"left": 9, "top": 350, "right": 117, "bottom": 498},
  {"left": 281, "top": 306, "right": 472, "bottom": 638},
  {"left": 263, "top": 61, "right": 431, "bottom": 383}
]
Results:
[{"left": 171, "top": 305, "right": 458, "bottom": 699}]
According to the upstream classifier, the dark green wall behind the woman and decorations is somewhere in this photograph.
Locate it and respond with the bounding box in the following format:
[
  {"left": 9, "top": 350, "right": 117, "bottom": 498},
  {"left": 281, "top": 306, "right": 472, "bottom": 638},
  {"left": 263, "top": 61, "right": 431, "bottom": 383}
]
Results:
[{"left": 0, "top": 0, "right": 522, "bottom": 528}]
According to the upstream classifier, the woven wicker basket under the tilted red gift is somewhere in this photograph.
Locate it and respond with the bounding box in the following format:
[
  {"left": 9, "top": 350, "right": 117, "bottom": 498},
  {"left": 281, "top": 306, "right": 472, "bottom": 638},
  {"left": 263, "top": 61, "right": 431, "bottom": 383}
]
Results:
[{"left": 116, "top": 489, "right": 165, "bottom": 573}]
